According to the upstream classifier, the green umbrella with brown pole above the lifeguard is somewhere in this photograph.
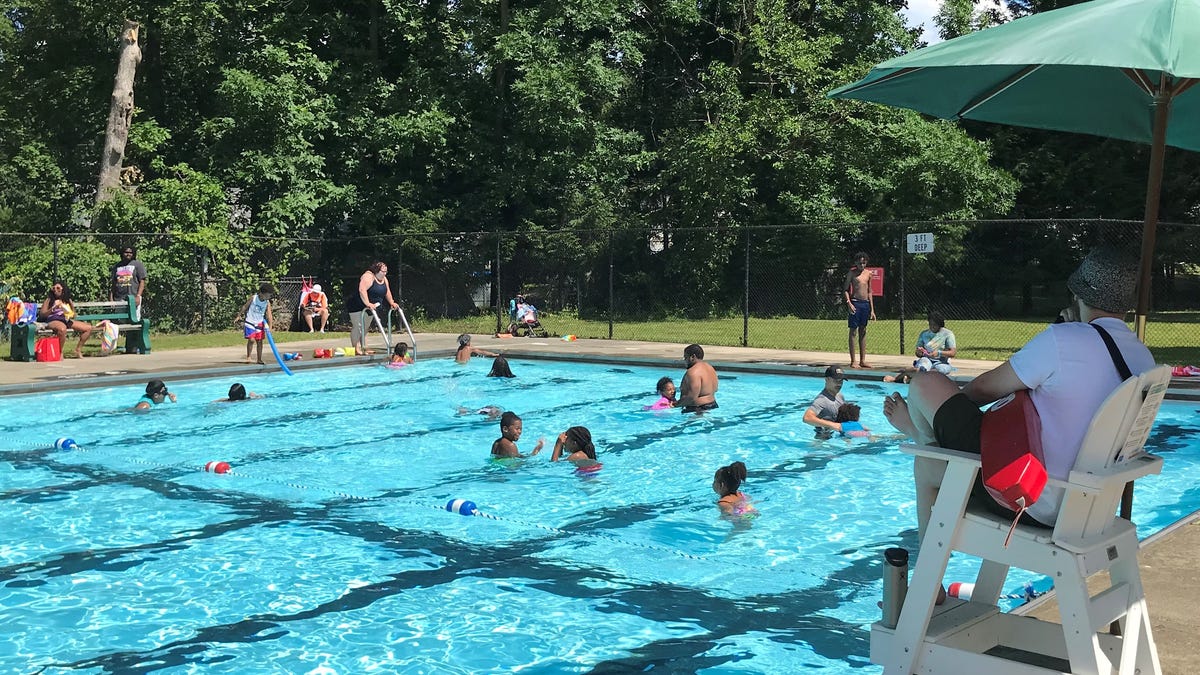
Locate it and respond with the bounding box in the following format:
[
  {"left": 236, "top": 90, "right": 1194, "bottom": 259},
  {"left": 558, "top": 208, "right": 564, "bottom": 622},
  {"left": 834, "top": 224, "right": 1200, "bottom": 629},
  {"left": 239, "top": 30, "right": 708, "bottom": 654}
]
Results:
[{"left": 829, "top": 0, "right": 1200, "bottom": 340}]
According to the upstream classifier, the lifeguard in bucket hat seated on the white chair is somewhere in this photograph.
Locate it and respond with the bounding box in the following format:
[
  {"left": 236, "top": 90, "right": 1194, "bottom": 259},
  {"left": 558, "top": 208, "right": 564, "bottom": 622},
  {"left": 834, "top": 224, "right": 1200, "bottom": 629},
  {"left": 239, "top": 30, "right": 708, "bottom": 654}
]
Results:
[{"left": 883, "top": 247, "right": 1154, "bottom": 537}]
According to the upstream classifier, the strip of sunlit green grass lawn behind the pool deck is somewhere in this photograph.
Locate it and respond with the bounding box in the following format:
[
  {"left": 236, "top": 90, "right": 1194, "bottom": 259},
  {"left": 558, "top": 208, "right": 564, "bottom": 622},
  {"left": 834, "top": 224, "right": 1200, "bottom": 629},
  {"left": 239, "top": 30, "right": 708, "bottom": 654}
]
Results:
[{"left": 79, "top": 313, "right": 1200, "bottom": 364}]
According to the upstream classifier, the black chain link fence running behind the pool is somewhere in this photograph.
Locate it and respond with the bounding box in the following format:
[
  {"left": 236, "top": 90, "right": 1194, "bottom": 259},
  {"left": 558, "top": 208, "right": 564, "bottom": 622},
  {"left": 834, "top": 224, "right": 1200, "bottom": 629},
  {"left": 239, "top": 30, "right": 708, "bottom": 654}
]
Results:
[{"left": 0, "top": 220, "right": 1200, "bottom": 363}]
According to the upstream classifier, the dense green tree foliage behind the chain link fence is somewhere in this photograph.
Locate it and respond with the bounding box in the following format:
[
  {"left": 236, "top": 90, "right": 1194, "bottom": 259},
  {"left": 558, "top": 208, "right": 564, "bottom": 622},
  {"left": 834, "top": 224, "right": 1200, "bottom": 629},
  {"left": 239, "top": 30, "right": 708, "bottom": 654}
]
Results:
[{"left": 0, "top": 0, "right": 1099, "bottom": 328}]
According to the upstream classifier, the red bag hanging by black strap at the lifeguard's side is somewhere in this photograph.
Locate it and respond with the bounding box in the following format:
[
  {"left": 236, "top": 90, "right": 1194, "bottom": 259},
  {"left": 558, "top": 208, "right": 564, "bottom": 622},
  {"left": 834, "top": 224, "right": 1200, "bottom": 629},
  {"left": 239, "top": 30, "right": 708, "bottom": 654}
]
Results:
[{"left": 979, "top": 389, "right": 1048, "bottom": 546}]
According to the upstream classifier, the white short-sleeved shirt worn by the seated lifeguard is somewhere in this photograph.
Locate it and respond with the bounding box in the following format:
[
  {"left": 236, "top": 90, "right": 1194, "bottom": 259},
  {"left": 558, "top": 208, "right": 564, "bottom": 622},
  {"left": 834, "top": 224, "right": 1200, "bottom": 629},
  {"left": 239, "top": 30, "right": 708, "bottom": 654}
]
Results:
[{"left": 1009, "top": 317, "right": 1154, "bottom": 525}]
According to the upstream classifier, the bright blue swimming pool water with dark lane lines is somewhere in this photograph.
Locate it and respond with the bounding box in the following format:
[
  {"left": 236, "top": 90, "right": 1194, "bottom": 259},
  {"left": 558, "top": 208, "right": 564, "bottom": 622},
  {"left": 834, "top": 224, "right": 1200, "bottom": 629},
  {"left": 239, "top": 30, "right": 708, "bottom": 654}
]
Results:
[{"left": 0, "top": 359, "right": 1200, "bottom": 674}]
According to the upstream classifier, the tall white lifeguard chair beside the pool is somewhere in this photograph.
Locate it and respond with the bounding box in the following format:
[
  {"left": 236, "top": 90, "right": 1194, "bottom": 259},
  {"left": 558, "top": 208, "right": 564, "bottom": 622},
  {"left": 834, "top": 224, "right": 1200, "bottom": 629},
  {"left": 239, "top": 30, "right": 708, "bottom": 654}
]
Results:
[{"left": 871, "top": 366, "right": 1171, "bottom": 675}]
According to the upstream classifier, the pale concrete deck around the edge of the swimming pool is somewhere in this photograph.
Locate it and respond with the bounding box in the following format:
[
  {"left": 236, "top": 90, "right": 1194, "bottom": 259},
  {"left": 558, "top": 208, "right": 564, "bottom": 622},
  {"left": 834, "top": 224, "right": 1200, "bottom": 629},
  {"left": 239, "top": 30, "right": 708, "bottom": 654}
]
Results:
[{"left": 0, "top": 334, "right": 1200, "bottom": 674}]
